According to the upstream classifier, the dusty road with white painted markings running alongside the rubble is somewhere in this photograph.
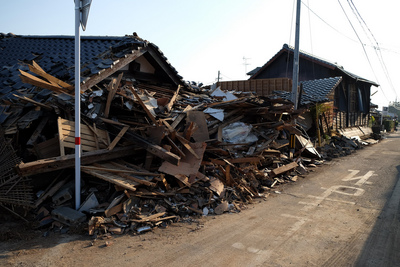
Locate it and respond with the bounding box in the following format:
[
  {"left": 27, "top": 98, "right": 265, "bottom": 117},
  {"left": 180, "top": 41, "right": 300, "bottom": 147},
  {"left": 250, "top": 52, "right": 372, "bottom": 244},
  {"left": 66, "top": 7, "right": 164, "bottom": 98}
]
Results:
[{"left": 0, "top": 133, "right": 400, "bottom": 267}]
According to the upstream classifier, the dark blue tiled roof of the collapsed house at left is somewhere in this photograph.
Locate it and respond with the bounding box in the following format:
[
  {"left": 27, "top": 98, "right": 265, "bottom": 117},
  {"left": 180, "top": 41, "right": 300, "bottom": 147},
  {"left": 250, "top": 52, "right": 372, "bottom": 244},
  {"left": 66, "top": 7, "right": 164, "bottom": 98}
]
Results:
[{"left": 0, "top": 34, "right": 181, "bottom": 98}]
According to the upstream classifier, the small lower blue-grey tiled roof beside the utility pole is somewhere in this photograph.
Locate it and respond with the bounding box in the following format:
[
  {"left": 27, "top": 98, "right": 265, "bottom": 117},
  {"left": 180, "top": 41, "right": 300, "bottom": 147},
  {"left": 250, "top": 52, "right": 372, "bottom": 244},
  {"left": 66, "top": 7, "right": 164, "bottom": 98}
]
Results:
[{"left": 275, "top": 77, "right": 342, "bottom": 105}]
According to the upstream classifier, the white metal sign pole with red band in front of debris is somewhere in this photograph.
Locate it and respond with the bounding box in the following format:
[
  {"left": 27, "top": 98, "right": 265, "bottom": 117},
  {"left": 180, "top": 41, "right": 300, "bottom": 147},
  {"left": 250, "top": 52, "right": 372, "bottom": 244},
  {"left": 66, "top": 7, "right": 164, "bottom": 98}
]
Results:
[{"left": 75, "top": 0, "right": 81, "bottom": 209}]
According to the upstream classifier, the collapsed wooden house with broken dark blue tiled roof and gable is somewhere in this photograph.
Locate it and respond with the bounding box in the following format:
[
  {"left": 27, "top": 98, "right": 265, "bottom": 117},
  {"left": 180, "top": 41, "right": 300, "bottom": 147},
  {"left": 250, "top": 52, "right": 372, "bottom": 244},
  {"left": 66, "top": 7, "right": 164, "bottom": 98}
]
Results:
[{"left": 0, "top": 34, "right": 183, "bottom": 206}]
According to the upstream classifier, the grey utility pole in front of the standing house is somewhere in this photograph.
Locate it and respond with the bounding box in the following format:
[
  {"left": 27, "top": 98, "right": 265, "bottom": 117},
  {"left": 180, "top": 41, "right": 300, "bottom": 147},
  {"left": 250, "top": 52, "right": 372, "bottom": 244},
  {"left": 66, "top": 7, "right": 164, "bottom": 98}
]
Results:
[{"left": 292, "top": 0, "right": 301, "bottom": 110}]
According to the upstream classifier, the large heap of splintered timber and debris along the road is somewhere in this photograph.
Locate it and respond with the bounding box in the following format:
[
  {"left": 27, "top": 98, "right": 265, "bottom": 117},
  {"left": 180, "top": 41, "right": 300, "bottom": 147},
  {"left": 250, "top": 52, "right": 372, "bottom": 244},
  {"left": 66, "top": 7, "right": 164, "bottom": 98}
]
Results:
[{"left": 0, "top": 60, "right": 340, "bottom": 237}]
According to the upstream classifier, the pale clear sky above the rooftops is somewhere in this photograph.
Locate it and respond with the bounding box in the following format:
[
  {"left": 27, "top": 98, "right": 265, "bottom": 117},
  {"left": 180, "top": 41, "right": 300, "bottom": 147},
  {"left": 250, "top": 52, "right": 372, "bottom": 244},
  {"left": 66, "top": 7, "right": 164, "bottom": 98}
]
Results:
[{"left": 0, "top": 0, "right": 400, "bottom": 108}]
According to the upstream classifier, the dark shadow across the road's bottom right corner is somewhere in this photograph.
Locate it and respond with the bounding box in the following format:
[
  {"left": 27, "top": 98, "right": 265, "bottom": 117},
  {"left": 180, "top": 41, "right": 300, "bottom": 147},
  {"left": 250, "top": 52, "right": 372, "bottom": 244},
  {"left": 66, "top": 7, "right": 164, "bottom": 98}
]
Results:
[{"left": 354, "top": 164, "right": 400, "bottom": 267}]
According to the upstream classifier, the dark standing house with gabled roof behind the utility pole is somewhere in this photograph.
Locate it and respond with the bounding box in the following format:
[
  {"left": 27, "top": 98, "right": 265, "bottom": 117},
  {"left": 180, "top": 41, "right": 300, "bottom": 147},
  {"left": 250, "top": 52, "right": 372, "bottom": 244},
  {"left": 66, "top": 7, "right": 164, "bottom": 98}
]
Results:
[{"left": 248, "top": 44, "right": 379, "bottom": 134}]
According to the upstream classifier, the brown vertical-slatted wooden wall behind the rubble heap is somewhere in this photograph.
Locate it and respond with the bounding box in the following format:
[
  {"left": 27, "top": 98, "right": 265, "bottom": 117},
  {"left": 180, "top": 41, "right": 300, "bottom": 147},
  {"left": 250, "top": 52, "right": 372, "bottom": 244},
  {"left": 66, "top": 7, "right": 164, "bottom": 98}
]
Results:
[{"left": 217, "top": 78, "right": 292, "bottom": 96}]
